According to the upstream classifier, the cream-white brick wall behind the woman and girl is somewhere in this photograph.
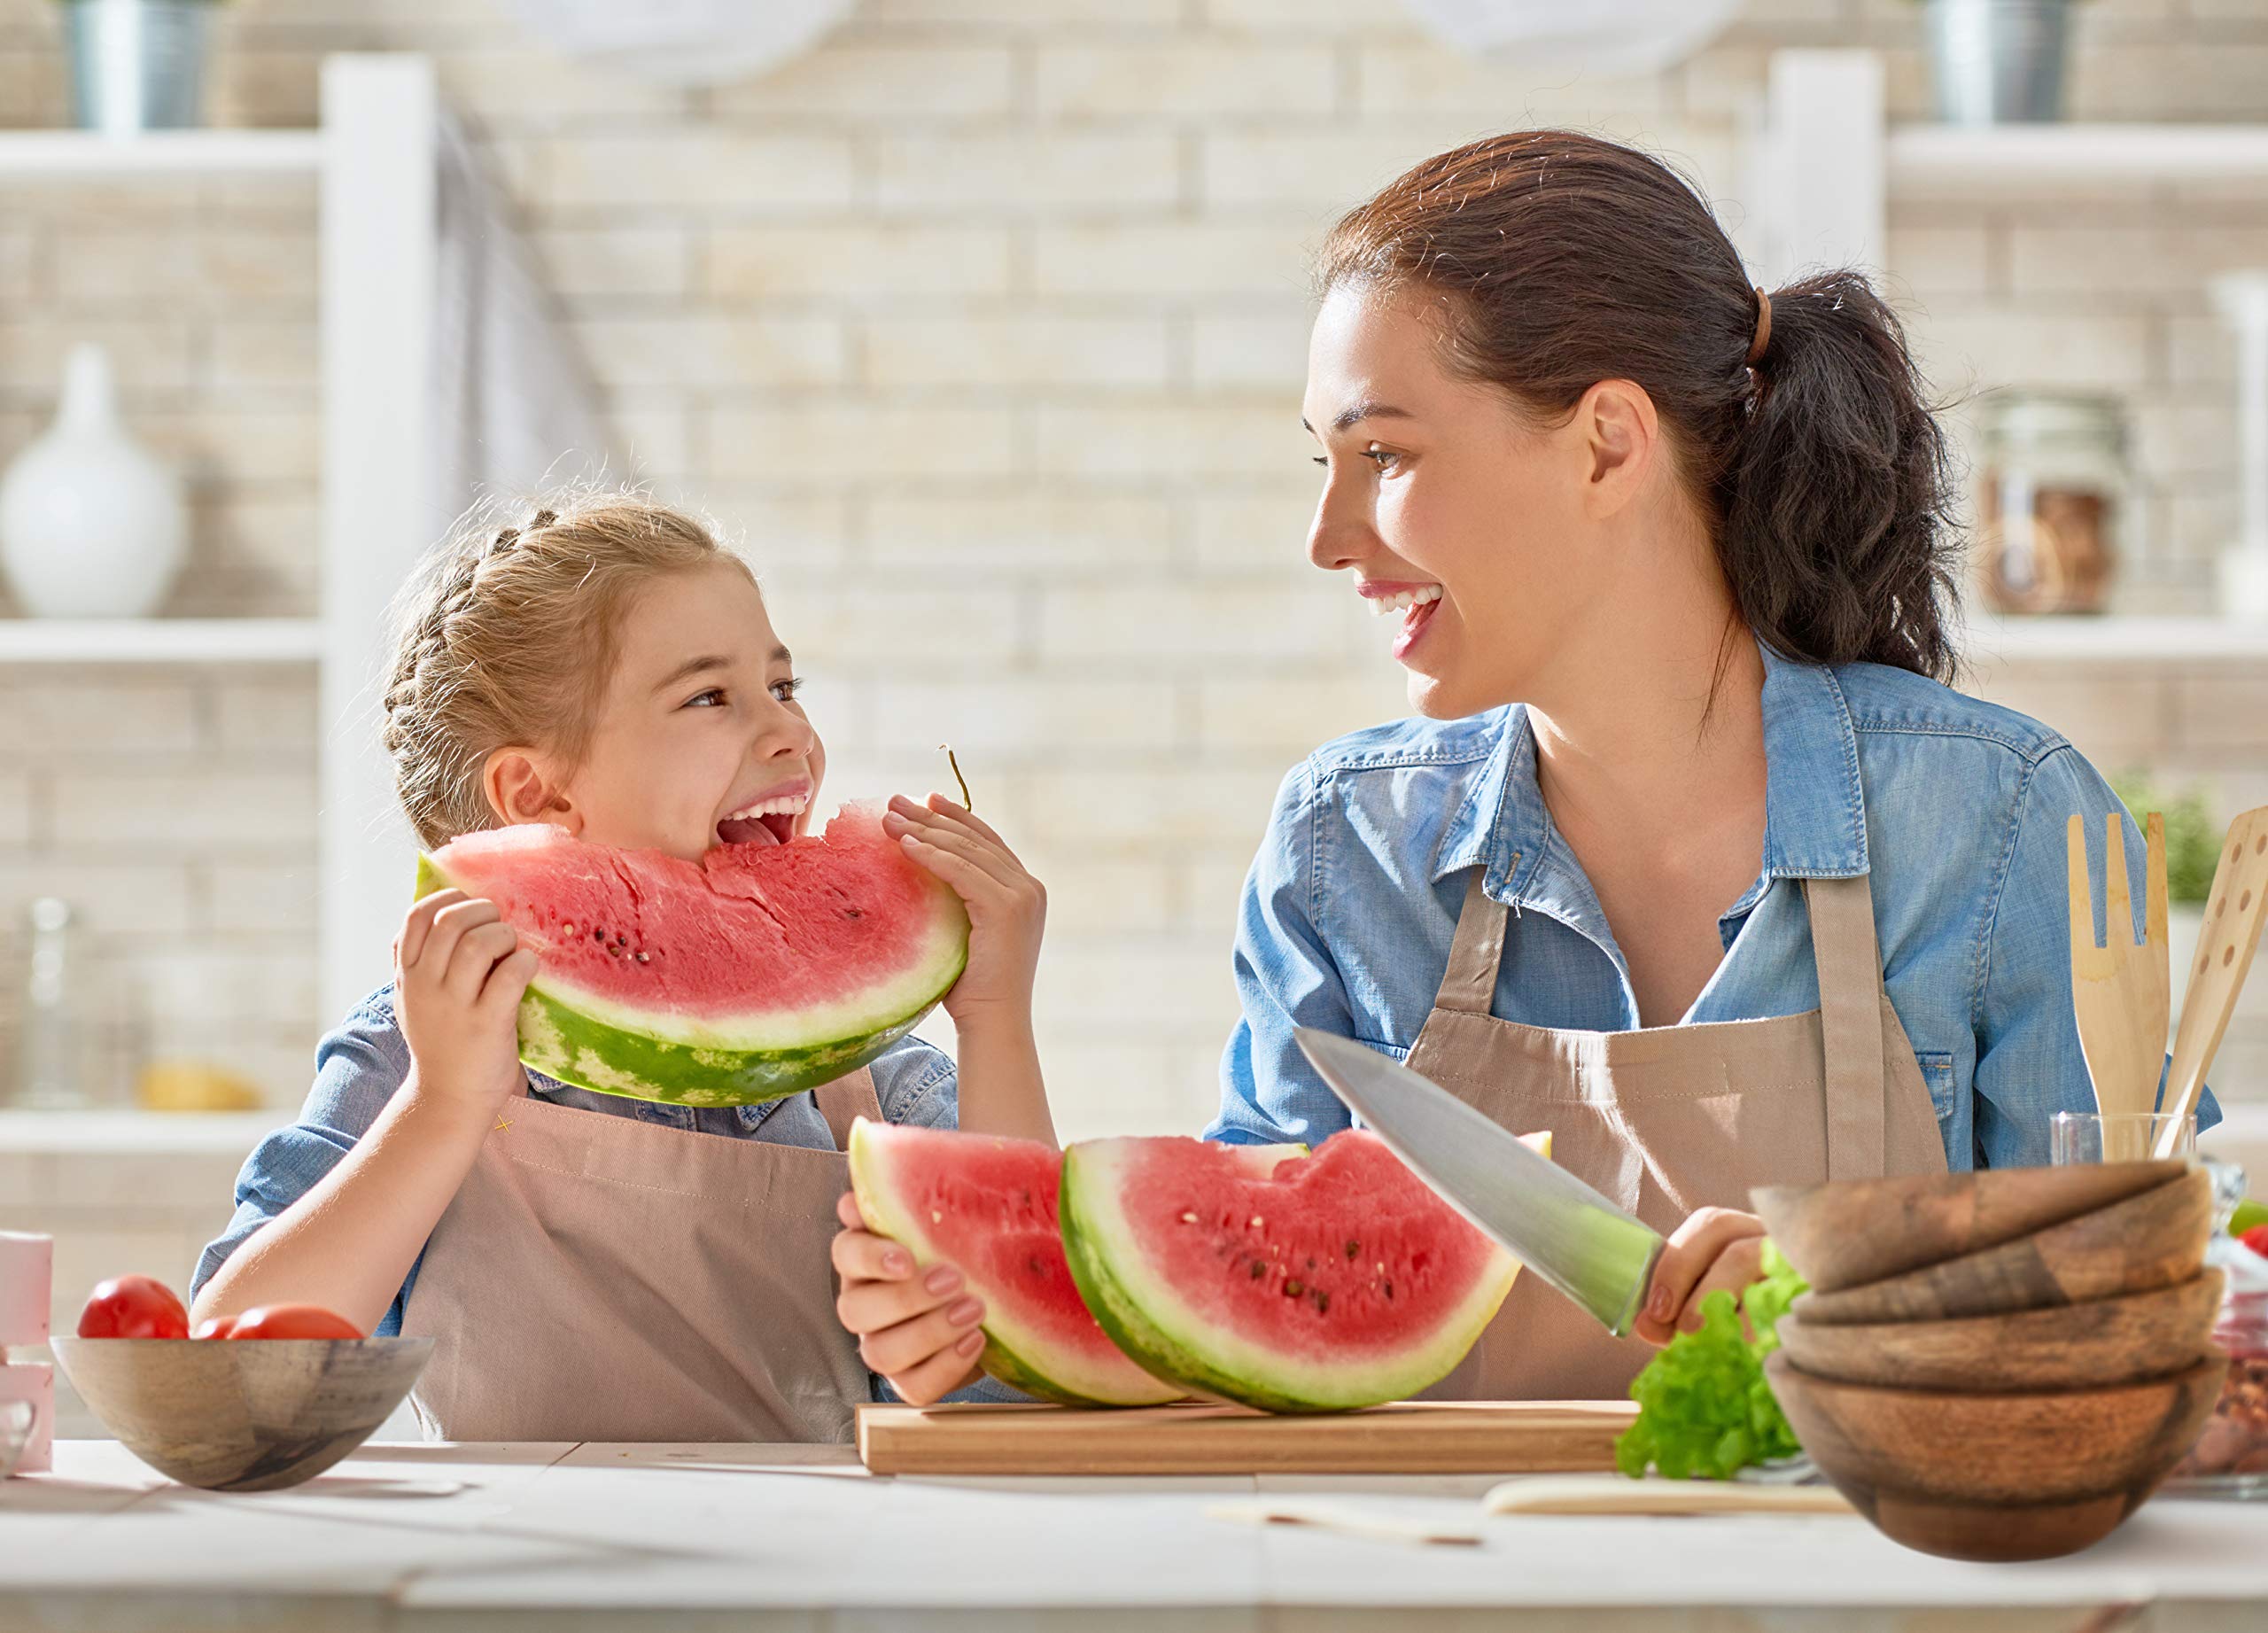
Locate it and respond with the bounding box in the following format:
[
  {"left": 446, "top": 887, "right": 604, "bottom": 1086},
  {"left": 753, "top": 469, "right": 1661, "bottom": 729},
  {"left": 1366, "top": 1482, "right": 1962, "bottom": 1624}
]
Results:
[{"left": 0, "top": 0, "right": 2268, "bottom": 1134}]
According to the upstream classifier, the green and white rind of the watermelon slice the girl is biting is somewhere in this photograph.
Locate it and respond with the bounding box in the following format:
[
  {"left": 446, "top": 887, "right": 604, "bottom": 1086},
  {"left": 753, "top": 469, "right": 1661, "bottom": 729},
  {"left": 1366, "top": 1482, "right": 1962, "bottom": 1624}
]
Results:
[{"left": 417, "top": 855, "right": 968, "bottom": 1107}]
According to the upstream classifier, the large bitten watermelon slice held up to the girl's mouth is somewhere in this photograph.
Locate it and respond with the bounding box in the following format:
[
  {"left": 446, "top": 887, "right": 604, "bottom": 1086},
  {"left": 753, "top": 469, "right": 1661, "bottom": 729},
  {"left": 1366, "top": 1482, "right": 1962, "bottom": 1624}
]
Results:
[{"left": 417, "top": 803, "right": 968, "bottom": 1107}]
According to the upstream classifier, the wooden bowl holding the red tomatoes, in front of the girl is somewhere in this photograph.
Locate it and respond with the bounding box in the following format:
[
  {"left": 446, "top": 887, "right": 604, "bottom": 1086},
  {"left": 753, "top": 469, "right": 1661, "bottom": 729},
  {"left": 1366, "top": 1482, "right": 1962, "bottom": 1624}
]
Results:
[{"left": 50, "top": 1338, "right": 433, "bottom": 1490}]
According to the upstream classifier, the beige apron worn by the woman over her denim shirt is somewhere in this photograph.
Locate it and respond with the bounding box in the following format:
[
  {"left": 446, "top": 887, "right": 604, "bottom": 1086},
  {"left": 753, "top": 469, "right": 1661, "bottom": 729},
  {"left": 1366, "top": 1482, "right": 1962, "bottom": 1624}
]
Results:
[{"left": 1409, "top": 871, "right": 1946, "bottom": 1399}]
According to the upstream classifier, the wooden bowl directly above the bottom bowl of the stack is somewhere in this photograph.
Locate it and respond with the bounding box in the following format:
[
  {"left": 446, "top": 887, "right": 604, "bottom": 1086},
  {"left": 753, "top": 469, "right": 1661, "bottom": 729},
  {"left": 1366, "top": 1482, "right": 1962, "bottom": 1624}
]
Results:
[{"left": 1778, "top": 1270, "right": 2223, "bottom": 1395}]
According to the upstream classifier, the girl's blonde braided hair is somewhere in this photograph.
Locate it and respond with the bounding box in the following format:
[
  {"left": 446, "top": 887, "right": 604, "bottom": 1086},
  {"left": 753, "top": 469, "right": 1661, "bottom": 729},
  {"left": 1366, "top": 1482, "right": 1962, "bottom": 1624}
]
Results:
[{"left": 385, "top": 490, "right": 753, "bottom": 848}]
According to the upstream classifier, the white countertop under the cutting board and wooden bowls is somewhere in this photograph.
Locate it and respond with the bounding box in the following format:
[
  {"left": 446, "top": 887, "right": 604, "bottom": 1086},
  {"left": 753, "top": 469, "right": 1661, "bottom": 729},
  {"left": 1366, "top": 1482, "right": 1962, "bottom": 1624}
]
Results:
[{"left": 13, "top": 1440, "right": 2268, "bottom": 1633}]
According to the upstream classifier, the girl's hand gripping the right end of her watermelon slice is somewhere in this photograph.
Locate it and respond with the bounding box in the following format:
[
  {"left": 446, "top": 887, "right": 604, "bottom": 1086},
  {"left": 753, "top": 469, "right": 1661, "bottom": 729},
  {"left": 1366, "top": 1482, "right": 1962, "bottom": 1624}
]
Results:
[{"left": 882, "top": 794, "right": 1048, "bottom": 1028}]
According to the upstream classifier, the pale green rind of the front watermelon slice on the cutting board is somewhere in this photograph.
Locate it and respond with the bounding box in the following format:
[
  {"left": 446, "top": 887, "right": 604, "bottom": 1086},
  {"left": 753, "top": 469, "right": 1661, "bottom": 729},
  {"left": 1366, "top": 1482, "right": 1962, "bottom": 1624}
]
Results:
[{"left": 1057, "top": 1141, "right": 1519, "bottom": 1413}]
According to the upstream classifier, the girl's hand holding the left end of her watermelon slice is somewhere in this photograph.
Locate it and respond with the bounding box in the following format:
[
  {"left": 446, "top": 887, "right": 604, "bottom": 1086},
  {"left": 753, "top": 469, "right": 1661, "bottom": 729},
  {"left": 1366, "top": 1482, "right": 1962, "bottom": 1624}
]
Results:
[{"left": 394, "top": 889, "right": 535, "bottom": 1111}]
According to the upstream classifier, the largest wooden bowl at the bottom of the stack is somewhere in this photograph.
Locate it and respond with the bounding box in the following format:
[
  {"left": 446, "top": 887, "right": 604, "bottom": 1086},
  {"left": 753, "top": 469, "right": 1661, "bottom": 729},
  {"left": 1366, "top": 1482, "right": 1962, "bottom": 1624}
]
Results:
[{"left": 1765, "top": 1352, "right": 2227, "bottom": 1560}]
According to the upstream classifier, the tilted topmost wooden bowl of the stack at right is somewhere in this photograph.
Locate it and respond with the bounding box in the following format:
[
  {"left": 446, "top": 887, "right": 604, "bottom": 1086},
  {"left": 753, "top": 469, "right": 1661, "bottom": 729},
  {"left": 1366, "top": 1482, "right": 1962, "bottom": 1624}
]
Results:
[{"left": 1749, "top": 1162, "right": 2184, "bottom": 1293}]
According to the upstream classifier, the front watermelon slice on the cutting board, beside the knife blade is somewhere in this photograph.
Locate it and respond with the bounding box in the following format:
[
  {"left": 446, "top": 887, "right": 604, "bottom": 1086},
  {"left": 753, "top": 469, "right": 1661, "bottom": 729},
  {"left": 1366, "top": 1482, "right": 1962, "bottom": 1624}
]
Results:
[{"left": 1061, "top": 1130, "right": 1519, "bottom": 1413}]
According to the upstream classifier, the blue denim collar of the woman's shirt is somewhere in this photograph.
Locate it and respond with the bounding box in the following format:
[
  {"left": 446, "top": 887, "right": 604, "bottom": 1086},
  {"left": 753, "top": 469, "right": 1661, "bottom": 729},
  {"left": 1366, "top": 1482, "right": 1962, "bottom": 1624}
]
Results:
[{"left": 1433, "top": 642, "right": 1868, "bottom": 905}]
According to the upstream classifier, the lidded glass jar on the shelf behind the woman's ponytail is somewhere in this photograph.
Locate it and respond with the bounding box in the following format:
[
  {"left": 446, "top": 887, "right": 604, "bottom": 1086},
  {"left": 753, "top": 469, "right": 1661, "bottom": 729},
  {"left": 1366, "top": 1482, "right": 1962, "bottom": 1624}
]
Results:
[{"left": 1976, "top": 393, "right": 2134, "bottom": 612}]
